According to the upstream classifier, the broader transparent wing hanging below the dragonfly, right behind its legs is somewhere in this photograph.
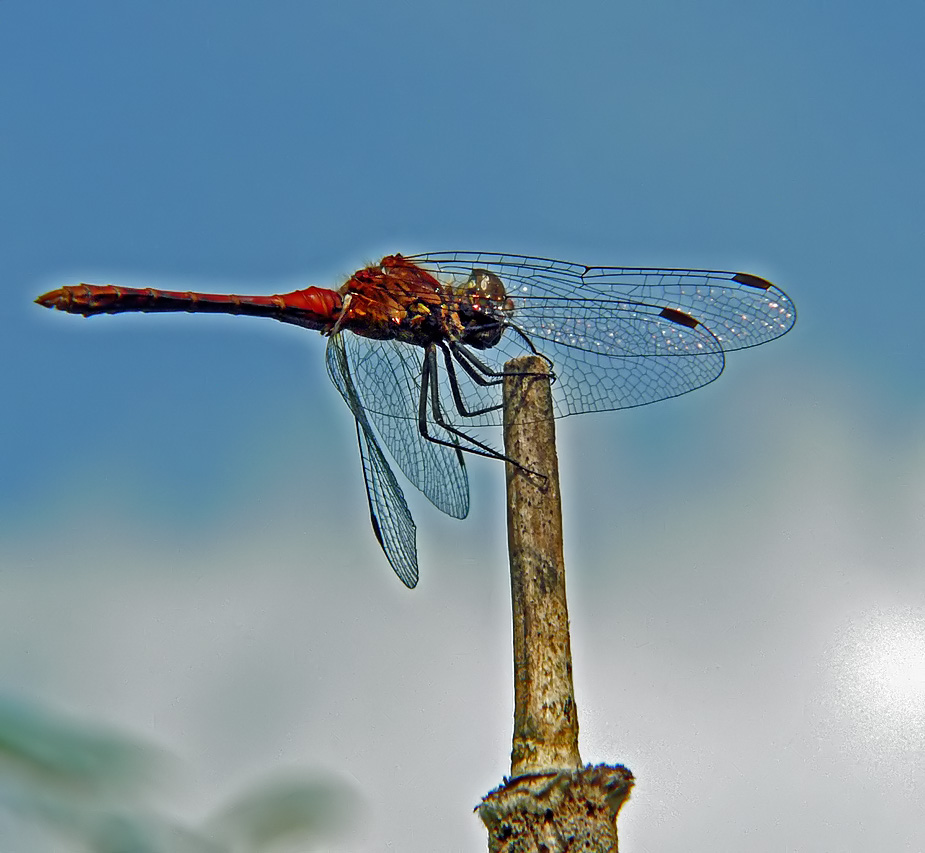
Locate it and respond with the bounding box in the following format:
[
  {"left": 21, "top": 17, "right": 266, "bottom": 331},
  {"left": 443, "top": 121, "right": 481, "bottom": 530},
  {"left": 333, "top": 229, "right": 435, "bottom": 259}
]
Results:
[{"left": 329, "top": 332, "right": 469, "bottom": 518}]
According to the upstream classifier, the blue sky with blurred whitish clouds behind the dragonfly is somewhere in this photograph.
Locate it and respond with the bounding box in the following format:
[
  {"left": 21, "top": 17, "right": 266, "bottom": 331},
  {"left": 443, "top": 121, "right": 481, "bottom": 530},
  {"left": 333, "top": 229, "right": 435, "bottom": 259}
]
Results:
[{"left": 0, "top": 0, "right": 925, "bottom": 851}]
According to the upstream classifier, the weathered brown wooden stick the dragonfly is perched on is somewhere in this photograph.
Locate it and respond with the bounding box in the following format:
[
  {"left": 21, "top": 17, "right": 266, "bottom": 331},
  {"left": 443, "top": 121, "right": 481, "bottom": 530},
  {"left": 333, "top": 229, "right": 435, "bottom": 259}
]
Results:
[{"left": 479, "top": 356, "right": 633, "bottom": 853}]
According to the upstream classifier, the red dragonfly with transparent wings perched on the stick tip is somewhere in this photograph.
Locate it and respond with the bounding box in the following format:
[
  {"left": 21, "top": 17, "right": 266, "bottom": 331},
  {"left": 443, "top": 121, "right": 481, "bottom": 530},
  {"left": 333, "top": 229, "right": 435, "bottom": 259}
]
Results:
[{"left": 36, "top": 252, "right": 796, "bottom": 588}]
